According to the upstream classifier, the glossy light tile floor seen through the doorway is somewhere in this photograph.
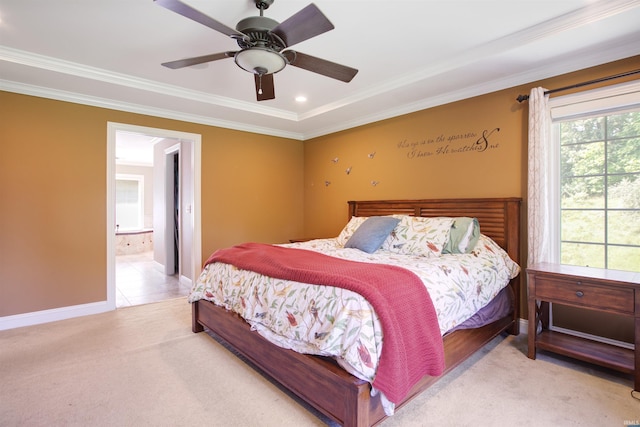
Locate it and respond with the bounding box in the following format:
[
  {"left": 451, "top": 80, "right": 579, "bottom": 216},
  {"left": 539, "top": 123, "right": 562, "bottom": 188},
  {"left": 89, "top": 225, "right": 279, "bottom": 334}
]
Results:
[{"left": 116, "top": 252, "right": 190, "bottom": 307}]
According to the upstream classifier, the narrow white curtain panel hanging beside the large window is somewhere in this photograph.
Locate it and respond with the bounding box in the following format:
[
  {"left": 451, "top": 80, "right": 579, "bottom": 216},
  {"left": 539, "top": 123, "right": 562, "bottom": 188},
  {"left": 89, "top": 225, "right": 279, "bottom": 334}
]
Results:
[{"left": 527, "top": 87, "right": 553, "bottom": 265}]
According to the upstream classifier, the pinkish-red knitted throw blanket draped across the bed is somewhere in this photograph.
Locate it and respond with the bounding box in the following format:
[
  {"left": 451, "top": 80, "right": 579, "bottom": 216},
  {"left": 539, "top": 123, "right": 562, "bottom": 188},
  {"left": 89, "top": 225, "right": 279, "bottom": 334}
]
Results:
[{"left": 205, "top": 243, "right": 445, "bottom": 403}]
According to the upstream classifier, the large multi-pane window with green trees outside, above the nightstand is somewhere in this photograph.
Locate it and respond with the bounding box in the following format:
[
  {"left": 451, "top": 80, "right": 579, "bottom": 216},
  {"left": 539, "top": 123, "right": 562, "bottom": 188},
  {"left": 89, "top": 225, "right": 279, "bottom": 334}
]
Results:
[{"left": 549, "top": 83, "right": 640, "bottom": 271}]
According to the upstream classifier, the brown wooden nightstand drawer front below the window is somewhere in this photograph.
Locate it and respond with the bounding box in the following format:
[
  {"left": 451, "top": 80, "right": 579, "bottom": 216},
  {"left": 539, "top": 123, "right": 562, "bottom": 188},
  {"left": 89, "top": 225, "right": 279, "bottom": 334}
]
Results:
[{"left": 536, "top": 277, "right": 634, "bottom": 314}]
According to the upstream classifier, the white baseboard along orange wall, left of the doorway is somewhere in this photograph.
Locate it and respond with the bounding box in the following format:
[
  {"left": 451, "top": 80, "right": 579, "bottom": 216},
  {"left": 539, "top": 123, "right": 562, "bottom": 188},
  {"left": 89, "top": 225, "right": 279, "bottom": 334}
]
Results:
[{"left": 0, "top": 301, "right": 115, "bottom": 331}]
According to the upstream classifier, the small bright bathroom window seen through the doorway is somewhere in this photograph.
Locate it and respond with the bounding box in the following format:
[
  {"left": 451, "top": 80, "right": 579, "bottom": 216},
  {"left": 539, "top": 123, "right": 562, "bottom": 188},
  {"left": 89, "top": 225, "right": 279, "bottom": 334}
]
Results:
[{"left": 116, "top": 174, "right": 144, "bottom": 231}]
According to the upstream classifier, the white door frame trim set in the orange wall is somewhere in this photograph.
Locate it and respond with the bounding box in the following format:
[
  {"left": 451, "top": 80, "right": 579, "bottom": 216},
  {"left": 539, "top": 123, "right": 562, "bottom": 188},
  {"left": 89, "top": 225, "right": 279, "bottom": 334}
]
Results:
[{"left": 106, "top": 122, "right": 202, "bottom": 310}]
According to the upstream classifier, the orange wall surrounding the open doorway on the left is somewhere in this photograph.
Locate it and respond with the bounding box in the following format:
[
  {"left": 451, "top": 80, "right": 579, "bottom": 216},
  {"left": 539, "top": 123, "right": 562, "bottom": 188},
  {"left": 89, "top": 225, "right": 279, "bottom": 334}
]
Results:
[{"left": 0, "top": 92, "right": 304, "bottom": 317}]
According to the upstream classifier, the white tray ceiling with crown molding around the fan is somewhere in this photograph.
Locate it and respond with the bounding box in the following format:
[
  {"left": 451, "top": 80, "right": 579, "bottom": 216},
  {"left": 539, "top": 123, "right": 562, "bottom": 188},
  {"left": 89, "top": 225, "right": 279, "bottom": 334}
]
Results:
[{"left": 0, "top": 0, "right": 640, "bottom": 140}]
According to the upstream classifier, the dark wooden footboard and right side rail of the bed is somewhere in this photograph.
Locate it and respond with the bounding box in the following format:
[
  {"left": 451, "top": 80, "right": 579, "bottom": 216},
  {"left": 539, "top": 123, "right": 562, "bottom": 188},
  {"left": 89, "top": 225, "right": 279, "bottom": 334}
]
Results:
[{"left": 193, "top": 300, "right": 513, "bottom": 427}]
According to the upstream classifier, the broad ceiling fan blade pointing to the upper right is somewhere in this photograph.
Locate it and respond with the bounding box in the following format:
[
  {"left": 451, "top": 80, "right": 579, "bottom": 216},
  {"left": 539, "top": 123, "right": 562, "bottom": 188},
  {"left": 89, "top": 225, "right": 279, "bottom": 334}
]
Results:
[{"left": 271, "top": 3, "right": 334, "bottom": 47}]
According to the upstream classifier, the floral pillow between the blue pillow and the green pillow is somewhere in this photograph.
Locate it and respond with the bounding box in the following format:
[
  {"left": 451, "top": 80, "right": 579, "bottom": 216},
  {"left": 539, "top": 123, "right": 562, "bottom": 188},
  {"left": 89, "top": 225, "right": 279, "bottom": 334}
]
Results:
[{"left": 382, "top": 215, "right": 453, "bottom": 257}]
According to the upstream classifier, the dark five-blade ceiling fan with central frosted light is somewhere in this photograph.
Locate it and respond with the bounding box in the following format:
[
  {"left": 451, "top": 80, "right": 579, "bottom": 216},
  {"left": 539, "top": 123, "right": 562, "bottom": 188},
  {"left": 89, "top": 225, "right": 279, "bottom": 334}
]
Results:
[{"left": 154, "top": 0, "right": 358, "bottom": 101}]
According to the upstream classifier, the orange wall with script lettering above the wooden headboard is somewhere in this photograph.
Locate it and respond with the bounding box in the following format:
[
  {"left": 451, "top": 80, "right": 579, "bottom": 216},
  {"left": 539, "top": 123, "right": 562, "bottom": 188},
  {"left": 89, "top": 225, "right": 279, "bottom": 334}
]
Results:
[{"left": 305, "top": 89, "right": 526, "bottom": 237}]
